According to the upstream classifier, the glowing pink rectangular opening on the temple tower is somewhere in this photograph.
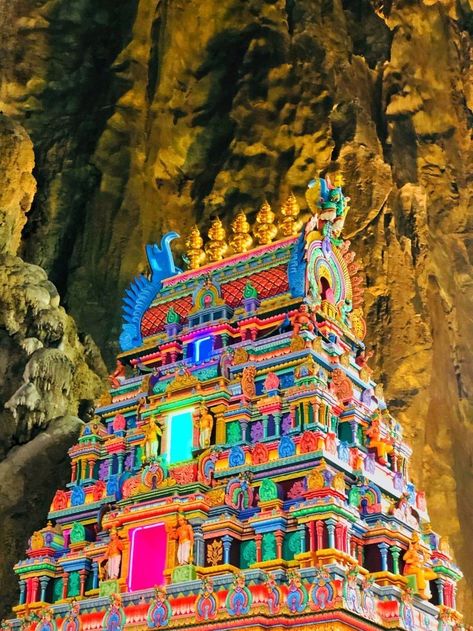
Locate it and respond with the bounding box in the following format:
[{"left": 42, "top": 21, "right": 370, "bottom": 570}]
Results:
[{"left": 128, "top": 523, "right": 167, "bottom": 591}]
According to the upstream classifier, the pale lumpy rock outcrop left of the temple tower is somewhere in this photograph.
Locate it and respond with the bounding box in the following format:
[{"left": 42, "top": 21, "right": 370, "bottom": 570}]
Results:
[{"left": 0, "top": 116, "right": 105, "bottom": 613}]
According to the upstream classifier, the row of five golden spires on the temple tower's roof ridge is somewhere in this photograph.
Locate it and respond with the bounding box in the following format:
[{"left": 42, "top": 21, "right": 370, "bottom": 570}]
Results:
[{"left": 186, "top": 193, "right": 302, "bottom": 269}]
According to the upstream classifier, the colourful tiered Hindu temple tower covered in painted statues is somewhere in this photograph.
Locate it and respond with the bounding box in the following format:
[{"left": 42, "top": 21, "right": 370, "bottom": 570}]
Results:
[{"left": 3, "top": 178, "right": 462, "bottom": 631}]
